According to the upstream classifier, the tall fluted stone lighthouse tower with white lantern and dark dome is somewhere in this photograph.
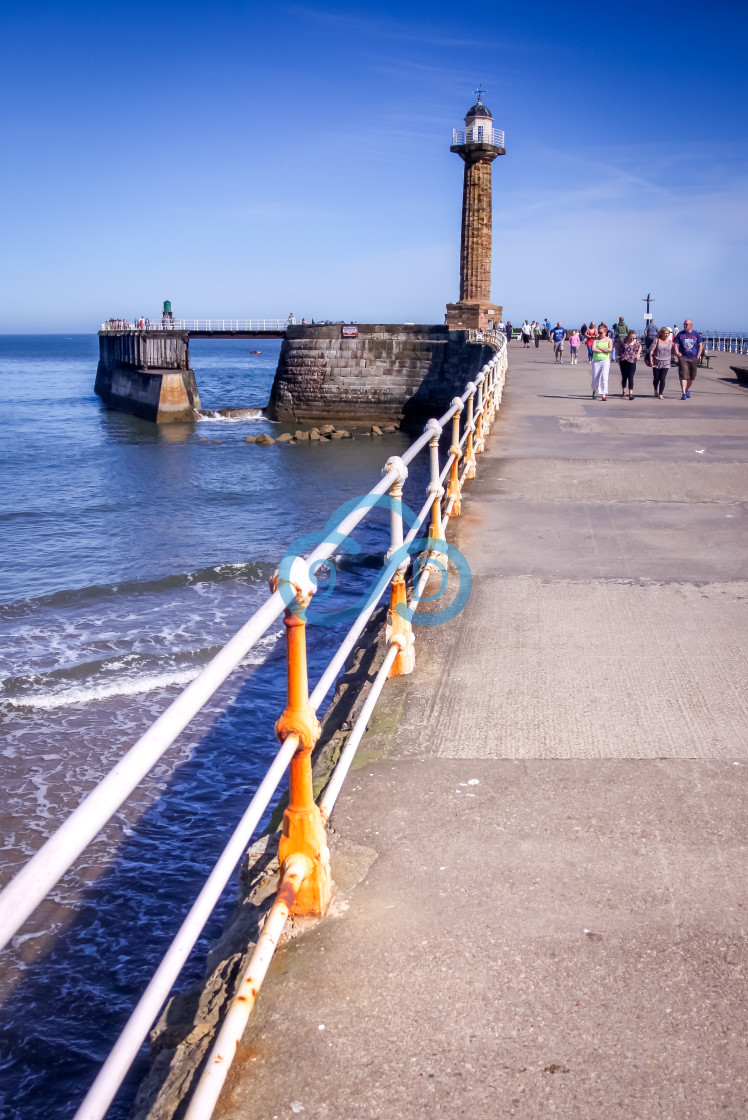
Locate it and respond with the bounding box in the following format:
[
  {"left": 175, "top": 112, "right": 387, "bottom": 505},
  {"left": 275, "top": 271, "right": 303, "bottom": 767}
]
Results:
[{"left": 447, "top": 90, "right": 506, "bottom": 330}]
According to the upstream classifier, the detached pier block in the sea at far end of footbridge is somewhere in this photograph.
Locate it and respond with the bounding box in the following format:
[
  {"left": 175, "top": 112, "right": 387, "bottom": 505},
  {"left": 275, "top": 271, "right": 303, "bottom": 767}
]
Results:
[{"left": 94, "top": 330, "right": 200, "bottom": 423}]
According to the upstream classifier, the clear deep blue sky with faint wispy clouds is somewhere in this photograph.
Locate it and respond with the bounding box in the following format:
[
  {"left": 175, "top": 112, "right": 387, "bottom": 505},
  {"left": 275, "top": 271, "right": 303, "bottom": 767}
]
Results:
[{"left": 0, "top": 0, "right": 748, "bottom": 332}]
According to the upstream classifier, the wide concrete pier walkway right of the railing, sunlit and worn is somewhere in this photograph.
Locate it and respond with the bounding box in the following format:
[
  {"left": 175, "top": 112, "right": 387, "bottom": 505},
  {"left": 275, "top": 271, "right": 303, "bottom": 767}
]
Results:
[{"left": 216, "top": 343, "right": 748, "bottom": 1120}]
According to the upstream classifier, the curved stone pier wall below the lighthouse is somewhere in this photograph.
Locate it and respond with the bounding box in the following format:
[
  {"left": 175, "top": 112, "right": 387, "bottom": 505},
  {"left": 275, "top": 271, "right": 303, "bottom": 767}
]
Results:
[{"left": 268, "top": 324, "right": 493, "bottom": 423}]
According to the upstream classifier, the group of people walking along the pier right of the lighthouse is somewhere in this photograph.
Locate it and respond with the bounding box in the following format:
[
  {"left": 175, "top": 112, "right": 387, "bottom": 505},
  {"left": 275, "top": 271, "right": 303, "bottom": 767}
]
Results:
[{"left": 539, "top": 315, "right": 704, "bottom": 401}]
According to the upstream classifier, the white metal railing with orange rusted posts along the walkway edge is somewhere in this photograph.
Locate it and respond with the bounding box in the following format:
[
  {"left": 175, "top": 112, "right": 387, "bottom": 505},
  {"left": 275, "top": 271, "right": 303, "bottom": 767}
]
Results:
[{"left": 0, "top": 336, "right": 506, "bottom": 1120}]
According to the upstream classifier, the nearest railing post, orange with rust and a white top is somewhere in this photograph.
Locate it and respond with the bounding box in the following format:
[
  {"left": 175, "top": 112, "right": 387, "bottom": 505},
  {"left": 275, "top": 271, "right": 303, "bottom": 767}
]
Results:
[{"left": 270, "top": 558, "right": 333, "bottom": 916}]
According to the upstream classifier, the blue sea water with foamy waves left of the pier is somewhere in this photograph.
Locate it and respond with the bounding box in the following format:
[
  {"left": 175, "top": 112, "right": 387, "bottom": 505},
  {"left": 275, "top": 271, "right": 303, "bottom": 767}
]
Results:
[{"left": 0, "top": 335, "right": 423, "bottom": 1120}]
